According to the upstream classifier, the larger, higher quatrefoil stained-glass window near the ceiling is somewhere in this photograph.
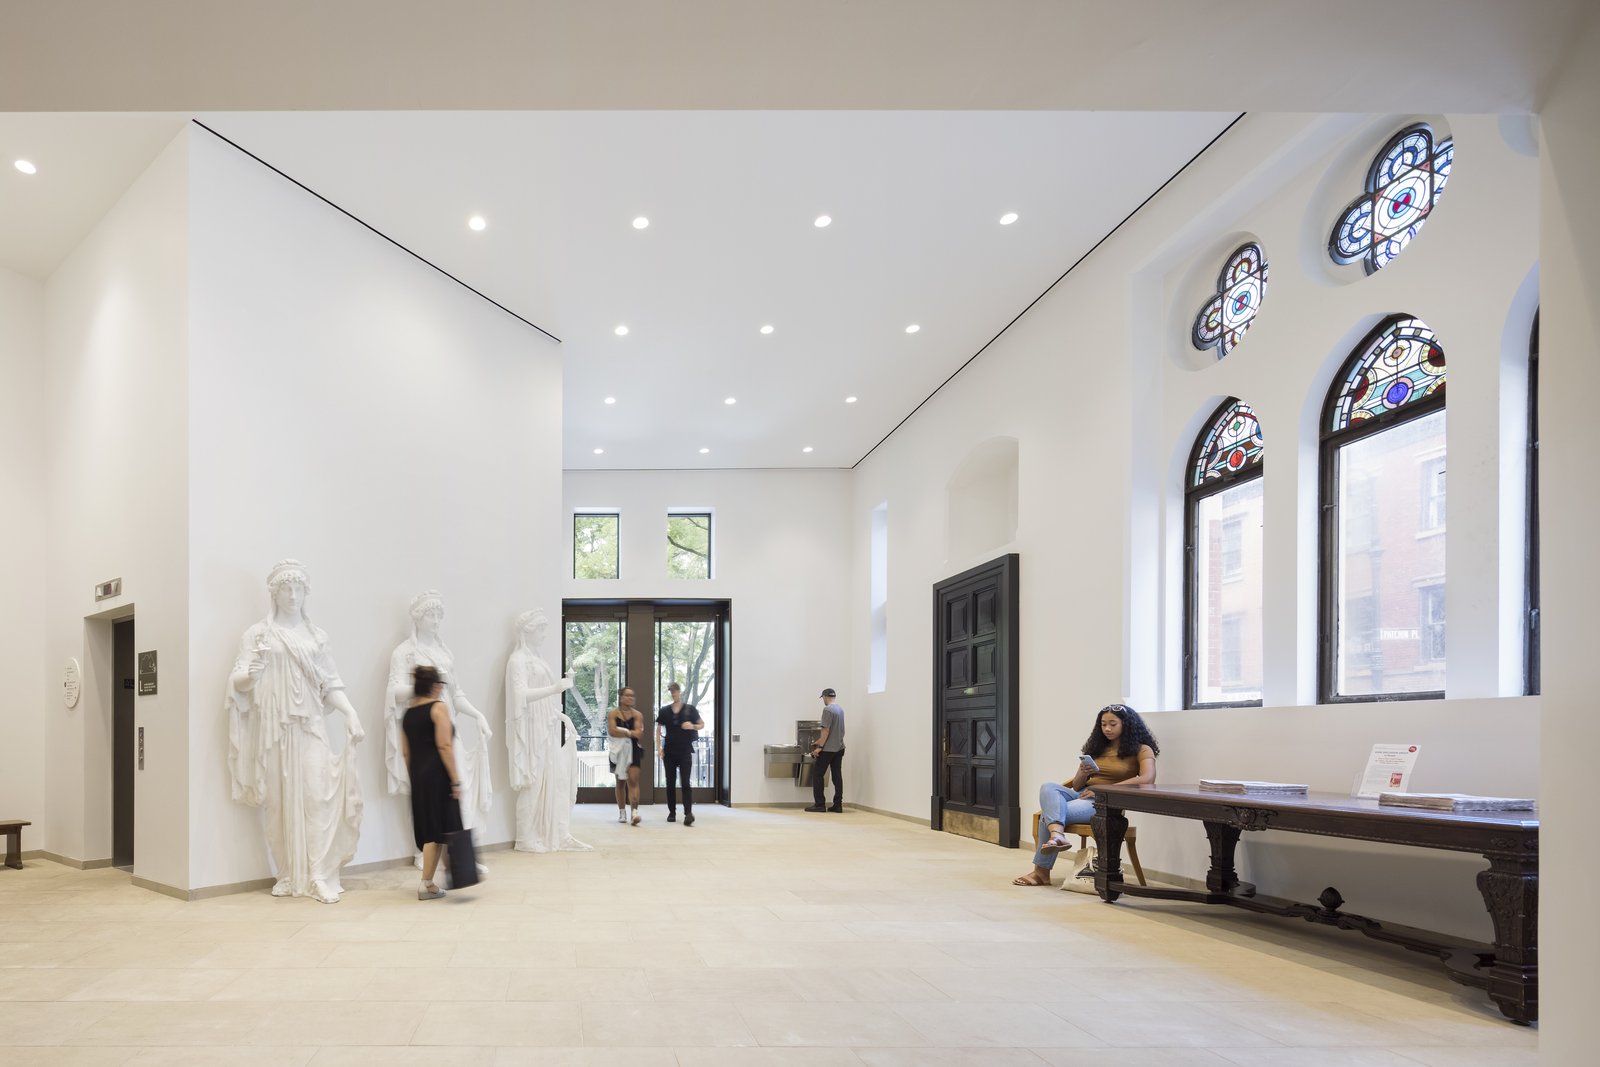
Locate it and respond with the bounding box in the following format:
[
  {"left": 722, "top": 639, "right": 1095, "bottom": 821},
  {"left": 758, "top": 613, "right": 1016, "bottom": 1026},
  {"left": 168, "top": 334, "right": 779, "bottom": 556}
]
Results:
[{"left": 1328, "top": 122, "right": 1456, "bottom": 274}]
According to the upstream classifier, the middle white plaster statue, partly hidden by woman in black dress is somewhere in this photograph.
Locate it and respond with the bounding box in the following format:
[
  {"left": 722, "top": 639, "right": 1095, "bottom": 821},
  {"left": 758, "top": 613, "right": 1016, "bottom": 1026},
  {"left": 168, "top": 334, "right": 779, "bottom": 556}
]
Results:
[{"left": 384, "top": 589, "right": 494, "bottom": 830}]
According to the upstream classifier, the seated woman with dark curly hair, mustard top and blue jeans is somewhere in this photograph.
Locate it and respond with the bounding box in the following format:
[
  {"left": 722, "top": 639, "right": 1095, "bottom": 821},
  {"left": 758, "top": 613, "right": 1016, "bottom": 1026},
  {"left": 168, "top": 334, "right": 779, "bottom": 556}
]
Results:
[{"left": 1011, "top": 704, "right": 1162, "bottom": 886}]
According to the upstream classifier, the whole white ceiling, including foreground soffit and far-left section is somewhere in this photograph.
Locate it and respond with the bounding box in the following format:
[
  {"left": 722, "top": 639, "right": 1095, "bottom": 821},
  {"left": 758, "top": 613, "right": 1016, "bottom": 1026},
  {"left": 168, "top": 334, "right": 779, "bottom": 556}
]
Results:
[{"left": 0, "top": 0, "right": 1597, "bottom": 467}]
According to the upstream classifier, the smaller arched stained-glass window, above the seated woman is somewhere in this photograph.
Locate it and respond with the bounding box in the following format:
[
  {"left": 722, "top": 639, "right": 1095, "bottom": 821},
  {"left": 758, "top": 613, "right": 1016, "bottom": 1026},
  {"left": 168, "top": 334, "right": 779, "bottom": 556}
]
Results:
[{"left": 1184, "top": 398, "right": 1264, "bottom": 707}]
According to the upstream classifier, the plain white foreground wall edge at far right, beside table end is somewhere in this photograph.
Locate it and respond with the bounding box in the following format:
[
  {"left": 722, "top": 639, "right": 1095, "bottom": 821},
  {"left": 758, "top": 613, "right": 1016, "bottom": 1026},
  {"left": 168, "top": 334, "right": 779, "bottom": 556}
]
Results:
[{"left": 1539, "top": 14, "right": 1600, "bottom": 1064}]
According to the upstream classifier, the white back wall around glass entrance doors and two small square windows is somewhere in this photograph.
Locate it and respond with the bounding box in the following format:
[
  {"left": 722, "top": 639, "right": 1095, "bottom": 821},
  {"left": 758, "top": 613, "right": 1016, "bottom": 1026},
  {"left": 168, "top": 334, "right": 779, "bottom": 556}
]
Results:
[{"left": 569, "top": 470, "right": 857, "bottom": 805}]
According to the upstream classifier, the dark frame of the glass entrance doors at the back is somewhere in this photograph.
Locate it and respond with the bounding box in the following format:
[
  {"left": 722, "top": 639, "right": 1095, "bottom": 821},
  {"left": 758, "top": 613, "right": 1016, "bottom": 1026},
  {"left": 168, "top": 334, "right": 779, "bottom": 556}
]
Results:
[{"left": 562, "top": 598, "right": 733, "bottom": 806}]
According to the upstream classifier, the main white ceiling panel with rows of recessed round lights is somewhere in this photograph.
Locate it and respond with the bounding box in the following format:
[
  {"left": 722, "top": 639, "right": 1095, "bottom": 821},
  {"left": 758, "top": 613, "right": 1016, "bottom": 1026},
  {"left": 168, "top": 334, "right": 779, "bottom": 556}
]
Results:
[{"left": 202, "top": 112, "right": 1234, "bottom": 469}]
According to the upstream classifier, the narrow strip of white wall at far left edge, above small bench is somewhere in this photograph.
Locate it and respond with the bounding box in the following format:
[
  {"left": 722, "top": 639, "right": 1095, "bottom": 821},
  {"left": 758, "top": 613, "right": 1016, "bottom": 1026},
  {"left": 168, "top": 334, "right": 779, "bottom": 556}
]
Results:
[{"left": 0, "top": 270, "right": 48, "bottom": 831}]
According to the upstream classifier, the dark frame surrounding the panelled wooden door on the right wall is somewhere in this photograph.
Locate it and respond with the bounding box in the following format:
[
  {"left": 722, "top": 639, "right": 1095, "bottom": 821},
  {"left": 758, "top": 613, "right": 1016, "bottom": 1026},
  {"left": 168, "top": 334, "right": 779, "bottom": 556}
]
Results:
[{"left": 928, "top": 552, "right": 1022, "bottom": 848}]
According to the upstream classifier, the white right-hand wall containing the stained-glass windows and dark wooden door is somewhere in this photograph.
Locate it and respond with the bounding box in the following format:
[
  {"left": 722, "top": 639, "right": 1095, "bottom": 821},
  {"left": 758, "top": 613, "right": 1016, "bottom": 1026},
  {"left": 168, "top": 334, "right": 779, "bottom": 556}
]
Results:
[{"left": 850, "top": 115, "right": 1539, "bottom": 936}]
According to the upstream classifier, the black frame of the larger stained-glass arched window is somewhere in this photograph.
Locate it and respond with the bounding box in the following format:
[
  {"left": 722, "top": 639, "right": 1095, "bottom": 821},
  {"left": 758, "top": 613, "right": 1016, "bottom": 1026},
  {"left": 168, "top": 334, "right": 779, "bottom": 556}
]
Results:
[{"left": 1317, "top": 314, "right": 1450, "bottom": 704}]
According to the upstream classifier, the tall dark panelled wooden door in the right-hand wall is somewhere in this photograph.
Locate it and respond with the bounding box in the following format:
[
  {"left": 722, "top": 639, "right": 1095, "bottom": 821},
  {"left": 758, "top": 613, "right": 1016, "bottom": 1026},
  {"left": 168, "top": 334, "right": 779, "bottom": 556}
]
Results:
[{"left": 931, "top": 553, "right": 1021, "bottom": 848}]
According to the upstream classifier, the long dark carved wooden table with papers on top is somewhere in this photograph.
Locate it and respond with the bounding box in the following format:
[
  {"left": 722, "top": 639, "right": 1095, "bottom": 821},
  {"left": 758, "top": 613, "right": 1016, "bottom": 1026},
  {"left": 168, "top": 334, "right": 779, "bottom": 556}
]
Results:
[{"left": 1093, "top": 785, "right": 1539, "bottom": 1025}]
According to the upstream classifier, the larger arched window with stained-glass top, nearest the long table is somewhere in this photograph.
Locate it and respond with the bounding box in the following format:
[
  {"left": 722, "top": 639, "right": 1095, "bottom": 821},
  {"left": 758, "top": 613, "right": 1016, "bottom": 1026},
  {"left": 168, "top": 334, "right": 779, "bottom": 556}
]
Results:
[{"left": 1320, "top": 315, "right": 1446, "bottom": 702}]
